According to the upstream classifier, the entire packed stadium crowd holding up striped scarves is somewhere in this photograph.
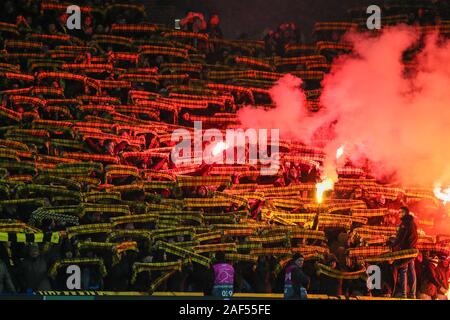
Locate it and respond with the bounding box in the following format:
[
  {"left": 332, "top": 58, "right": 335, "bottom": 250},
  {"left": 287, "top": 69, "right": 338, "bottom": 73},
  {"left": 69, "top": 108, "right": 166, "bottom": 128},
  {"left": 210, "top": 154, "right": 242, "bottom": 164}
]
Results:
[{"left": 0, "top": 0, "right": 450, "bottom": 299}]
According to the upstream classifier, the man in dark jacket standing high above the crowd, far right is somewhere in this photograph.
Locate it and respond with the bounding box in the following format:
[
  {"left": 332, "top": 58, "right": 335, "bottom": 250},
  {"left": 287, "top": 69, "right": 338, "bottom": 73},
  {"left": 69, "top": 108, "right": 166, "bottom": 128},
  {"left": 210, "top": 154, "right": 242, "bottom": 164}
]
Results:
[{"left": 388, "top": 207, "right": 418, "bottom": 299}]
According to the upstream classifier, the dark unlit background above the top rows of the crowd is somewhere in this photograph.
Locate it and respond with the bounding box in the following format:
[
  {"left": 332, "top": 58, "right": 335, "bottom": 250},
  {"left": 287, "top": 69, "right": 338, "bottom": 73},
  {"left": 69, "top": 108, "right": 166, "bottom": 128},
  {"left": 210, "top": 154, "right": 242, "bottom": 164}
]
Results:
[{"left": 142, "top": 0, "right": 383, "bottom": 39}]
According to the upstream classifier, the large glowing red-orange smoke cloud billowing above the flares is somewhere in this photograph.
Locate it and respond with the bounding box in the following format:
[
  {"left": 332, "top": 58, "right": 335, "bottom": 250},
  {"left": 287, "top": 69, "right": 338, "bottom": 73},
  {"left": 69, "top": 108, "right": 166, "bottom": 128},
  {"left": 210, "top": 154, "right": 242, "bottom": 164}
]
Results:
[{"left": 239, "top": 26, "right": 450, "bottom": 187}]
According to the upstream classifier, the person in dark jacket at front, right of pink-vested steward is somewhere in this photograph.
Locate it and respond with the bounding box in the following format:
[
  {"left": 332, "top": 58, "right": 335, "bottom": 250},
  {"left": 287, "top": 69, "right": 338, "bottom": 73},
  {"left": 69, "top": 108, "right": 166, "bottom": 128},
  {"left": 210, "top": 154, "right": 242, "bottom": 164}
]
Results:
[{"left": 284, "top": 253, "right": 310, "bottom": 299}]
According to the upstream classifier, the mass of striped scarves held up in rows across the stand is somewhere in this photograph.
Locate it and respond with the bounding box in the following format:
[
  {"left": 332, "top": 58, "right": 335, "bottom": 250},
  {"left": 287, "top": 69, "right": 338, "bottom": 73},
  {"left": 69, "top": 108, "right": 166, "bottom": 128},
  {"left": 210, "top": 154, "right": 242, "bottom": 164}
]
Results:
[{"left": 0, "top": 1, "right": 449, "bottom": 292}]
